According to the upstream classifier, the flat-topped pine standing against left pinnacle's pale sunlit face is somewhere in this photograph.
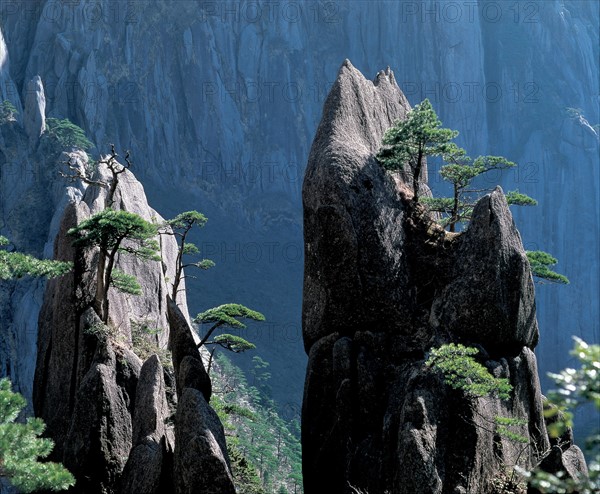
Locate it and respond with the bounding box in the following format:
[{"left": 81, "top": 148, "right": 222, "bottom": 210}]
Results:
[{"left": 68, "top": 209, "right": 160, "bottom": 324}]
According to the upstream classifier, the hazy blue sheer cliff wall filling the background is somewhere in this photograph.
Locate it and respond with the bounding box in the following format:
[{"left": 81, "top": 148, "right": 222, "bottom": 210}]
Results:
[{"left": 0, "top": 0, "right": 600, "bottom": 428}]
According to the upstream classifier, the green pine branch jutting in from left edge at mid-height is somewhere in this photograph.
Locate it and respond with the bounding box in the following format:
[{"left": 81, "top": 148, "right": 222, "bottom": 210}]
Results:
[{"left": 0, "top": 236, "right": 73, "bottom": 280}]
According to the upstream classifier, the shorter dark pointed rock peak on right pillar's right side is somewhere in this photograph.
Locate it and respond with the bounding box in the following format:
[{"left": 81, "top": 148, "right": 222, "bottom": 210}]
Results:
[{"left": 431, "top": 187, "right": 539, "bottom": 352}]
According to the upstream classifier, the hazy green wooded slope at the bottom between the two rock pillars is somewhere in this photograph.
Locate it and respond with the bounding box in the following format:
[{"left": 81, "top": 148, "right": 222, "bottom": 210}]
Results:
[{"left": 211, "top": 355, "right": 303, "bottom": 494}]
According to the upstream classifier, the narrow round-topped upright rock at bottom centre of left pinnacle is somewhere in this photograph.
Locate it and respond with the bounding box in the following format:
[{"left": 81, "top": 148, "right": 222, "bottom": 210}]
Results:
[{"left": 121, "top": 355, "right": 174, "bottom": 494}]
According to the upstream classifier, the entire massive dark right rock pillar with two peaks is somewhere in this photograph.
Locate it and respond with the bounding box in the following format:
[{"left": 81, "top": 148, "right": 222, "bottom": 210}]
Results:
[{"left": 302, "top": 61, "right": 582, "bottom": 494}]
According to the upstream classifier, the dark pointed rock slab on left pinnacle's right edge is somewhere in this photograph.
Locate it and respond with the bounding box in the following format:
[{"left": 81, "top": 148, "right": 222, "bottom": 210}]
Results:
[{"left": 167, "top": 298, "right": 212, "bottom": 402}]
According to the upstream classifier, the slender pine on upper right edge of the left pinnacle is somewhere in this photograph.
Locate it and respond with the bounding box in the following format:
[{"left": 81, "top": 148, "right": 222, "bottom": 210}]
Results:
[{"left": 160, "top": 211, "right": 215, "bottom": 301}]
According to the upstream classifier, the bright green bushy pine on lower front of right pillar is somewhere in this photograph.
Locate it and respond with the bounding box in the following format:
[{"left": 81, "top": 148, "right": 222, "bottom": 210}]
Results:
[{"left": 426, "top": 343, "right": 512, "bottom": 400}]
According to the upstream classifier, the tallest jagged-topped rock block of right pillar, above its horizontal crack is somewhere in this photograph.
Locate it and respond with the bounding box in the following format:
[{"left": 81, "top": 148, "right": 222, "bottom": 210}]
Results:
[{"left": 303, "top": 61, "right": 410, "bottom": 350}]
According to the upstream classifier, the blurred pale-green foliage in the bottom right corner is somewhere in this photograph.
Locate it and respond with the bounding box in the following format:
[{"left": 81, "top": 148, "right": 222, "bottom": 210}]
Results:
[{"left": 519, "top": 338, "right": 600, "bottom": 494}]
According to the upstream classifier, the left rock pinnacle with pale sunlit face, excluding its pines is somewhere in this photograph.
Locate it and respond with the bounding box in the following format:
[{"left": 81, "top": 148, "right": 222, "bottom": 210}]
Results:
[{"left": 33, "top": 151, "right": 235, "bottom": 494}]
